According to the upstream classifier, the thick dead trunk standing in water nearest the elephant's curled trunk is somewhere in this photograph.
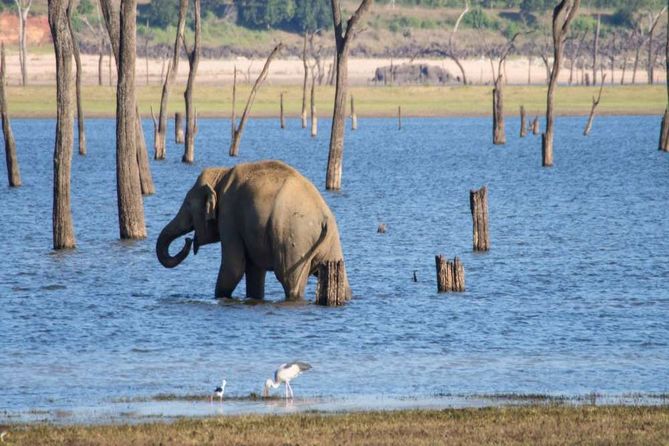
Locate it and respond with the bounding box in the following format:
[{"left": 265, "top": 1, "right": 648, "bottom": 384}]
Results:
[{"left": 100, "top": 0, "right": 146, "bottom": 239}]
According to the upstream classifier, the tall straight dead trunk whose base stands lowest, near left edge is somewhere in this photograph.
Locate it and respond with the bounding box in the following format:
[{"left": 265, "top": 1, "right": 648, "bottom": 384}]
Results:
[{"left": 48, "top": 0, "right": 76, "bottom": 249}]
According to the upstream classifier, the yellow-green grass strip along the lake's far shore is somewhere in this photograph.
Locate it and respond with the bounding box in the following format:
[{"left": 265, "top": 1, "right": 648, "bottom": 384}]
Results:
[{"left": 7, "top": 84, "right": 666, "bottom": 119}]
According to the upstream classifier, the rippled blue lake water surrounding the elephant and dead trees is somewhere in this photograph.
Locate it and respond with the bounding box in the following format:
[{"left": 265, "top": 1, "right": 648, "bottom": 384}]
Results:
[{"left": 0, "top": 117, "right": 669, "bottom": 420}]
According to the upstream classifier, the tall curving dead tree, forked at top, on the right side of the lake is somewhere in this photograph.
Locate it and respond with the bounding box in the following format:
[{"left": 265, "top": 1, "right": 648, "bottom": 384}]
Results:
[{"left": 541, "top": 0, "right": 581, "bottom": 167}]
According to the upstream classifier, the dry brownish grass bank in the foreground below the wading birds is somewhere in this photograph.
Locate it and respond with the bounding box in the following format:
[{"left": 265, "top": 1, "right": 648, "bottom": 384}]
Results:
[{"left": 3, "top": 405, "right": 669, "bottom": 446}]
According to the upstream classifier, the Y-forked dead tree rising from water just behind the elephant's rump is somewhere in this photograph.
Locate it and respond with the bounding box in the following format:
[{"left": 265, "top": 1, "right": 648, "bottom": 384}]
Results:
[{"left": 325, "top": 0, "right": 373, "bottom": 190}]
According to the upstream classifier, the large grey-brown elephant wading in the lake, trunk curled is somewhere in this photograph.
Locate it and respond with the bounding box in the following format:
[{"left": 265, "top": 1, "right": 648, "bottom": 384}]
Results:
[{"left": 156, "top": 160, "right": 350, "bottom": 300}]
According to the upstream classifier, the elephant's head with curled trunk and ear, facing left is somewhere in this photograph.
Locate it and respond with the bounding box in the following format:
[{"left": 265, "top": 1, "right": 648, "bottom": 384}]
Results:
[{"left": 156, "top": 169, "right": 223, "bottom": 268}]
